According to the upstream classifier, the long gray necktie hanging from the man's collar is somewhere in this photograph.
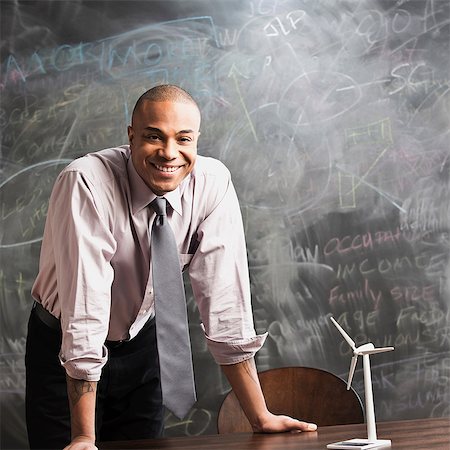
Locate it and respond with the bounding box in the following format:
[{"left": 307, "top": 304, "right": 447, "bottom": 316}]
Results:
[{"left": 151, "top": 197, "right": 196, "bottom": 419}]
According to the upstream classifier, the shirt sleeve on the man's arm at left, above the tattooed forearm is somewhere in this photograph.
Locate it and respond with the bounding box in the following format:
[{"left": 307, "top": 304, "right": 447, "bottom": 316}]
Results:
[{"left": 48, "top": 170, "right": 116, "bottom": 381}]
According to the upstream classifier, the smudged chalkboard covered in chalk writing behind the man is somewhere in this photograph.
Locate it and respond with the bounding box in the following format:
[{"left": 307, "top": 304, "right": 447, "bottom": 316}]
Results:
[{"left": 0, "top": 0, "right": 450, "bottom": 448}]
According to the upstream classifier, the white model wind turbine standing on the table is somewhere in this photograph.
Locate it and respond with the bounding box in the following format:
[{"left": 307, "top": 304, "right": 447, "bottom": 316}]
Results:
[{"left": 327, "top": 317, "right": 394, "bottom": 449}]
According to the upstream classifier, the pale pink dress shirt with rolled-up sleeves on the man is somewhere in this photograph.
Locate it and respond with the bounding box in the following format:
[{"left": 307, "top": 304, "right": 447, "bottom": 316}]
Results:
[{"left": 32, "top": 146, "right": 267, "bottom": 381}]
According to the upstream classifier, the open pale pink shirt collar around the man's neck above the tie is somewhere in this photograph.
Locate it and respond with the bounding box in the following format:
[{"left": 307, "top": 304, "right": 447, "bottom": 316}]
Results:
[{"left": 127, "top": 156, "right": 183, "bottom": 216}]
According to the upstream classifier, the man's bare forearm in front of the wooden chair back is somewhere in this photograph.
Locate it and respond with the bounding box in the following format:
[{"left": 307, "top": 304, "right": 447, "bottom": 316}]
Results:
[{"left": 221, "top": 358, "right": 269, "bottom": 431}]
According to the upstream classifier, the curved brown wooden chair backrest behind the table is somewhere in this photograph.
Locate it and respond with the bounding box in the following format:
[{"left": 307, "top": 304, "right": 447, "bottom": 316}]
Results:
[{"left": 217, "top": 367, "right": 364, "bottom": 434}]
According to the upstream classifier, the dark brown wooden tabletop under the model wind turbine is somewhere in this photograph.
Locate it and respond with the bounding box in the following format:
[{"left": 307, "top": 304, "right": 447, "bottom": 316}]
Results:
[{"left": 98, "top": 418, "right": 450, "bottom": 450}]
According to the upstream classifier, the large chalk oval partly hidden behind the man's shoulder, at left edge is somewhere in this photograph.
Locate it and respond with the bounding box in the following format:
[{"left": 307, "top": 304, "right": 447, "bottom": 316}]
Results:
[{"left": 0, "top": 159, "right": 72, "bottom": 248}]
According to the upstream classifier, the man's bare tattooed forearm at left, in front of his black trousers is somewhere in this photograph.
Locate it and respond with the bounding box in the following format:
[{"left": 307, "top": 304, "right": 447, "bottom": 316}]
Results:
[{"left": 66, "top": 375, "right": 97, "bottom": 443}]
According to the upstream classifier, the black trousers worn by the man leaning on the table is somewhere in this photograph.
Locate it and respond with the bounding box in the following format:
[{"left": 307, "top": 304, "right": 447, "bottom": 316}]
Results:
[{"left": 25, "top": 309, "right": 164, "bottom": 450}]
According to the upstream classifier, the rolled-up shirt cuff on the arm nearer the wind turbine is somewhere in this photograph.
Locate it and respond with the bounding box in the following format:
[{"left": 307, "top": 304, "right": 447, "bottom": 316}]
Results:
[{"left": 201, "top": 324, "right": 268, "bottom": 365}]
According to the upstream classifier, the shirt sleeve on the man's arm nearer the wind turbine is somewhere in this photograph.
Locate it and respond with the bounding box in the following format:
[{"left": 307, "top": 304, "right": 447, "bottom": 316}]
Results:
[{"left": 189, "top": 162, "right": 267, "bottom": 365}]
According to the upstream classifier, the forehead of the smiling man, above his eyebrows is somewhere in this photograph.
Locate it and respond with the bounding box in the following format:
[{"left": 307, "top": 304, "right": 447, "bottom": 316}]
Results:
[{"left": 133, "top": 100, "right": 200, "bottom": 131}]
